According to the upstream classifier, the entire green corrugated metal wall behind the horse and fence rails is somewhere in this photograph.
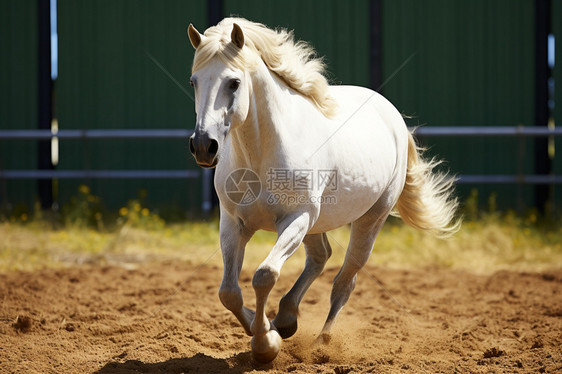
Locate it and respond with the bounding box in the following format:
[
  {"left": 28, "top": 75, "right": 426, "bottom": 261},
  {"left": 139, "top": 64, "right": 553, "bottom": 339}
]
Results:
[{"left": 0, "top": 0, "right": 562, "bottom": 216}]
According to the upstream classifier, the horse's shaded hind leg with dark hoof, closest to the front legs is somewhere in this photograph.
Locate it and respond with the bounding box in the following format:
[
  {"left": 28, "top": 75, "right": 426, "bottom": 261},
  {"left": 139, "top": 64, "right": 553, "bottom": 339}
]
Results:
[{"left": 272, "top": 233, "right": 332, "bottom": 339}]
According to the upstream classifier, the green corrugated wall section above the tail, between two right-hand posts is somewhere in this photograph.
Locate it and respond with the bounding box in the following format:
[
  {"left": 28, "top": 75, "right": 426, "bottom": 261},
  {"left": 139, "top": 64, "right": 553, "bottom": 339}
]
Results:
[{"left": 382, "top": 0, "right": 535, "bottom": 208}]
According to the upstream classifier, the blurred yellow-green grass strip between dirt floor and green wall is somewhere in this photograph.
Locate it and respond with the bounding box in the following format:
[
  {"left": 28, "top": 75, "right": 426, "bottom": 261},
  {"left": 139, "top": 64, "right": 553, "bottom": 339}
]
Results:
[{"left": 0, "top": 213, "right": 562, "bottom": 273}]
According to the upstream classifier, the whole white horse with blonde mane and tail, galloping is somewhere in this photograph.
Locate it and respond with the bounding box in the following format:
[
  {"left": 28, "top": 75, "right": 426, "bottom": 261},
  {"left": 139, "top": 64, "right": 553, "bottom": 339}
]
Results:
[{"left": 188, "top": 18, "right": 460, "bottom": 362}]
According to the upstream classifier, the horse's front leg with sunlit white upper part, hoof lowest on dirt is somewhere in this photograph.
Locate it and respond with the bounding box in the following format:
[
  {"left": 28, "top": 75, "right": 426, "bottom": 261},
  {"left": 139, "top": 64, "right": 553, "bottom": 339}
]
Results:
[{"left": 251, "top": 213, "right": 310, "bottom": 362}]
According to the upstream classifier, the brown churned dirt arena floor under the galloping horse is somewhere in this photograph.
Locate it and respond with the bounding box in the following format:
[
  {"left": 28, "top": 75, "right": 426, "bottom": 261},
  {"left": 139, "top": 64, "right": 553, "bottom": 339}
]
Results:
[{"left": 0, "top": 262, "right": 562, "bottom": 374}]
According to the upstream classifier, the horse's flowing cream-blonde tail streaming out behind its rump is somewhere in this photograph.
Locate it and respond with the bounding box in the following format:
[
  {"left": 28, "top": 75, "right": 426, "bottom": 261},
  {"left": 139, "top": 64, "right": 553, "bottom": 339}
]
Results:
[{"left": 392, "top": 133, "right": 461, "bottom": 238}]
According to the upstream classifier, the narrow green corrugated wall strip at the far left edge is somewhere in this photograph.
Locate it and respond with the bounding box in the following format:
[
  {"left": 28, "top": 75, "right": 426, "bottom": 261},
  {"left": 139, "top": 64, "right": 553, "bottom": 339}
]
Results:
[{"left": 0, "top": 0, "right": 38, "bottom": 212}]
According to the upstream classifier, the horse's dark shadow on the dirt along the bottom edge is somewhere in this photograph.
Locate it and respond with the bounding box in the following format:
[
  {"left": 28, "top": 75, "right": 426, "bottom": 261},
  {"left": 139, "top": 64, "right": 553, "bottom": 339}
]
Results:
[{"left": 95, "top": 352, "right": 267, "bottom": 374}]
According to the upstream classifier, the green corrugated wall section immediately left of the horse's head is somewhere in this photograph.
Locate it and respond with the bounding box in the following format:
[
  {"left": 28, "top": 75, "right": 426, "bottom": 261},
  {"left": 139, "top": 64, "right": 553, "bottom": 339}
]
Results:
[{"left": 57, "top": 0, "right": 206, "bottom": 215}]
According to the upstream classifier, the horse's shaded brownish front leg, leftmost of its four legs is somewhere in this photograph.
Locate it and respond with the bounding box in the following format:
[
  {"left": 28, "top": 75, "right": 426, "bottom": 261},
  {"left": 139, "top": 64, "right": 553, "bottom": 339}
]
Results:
[{"left": 219, "top": 212, "right": 255, "bottom": 336}]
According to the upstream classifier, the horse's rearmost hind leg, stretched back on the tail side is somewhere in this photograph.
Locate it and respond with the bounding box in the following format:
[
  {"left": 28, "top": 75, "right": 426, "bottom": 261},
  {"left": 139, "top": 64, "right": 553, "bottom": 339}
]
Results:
[{"left": 320, "top": 212, "right": 388, "bottom": 340}]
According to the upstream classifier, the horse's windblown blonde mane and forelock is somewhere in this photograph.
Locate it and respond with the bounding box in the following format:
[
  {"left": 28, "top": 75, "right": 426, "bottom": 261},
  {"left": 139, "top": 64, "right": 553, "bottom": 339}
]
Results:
[{"left": 192, "top": 18, "right": 336, "bottom": 117}]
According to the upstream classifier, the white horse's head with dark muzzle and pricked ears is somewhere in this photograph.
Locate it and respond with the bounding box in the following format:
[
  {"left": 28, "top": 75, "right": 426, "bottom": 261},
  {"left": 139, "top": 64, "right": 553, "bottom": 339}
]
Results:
[{"left": 188, "top": 23, "right": 250, "bottom": 168}]
